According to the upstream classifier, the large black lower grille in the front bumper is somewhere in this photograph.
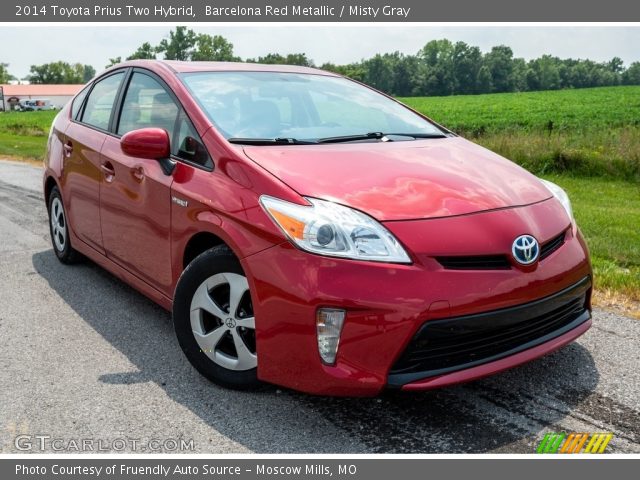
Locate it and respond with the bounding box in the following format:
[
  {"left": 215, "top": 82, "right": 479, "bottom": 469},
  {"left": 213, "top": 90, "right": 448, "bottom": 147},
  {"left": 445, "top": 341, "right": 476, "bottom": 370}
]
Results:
[{"left": 389, "top": 277, "right": 591, "bottom": 386}]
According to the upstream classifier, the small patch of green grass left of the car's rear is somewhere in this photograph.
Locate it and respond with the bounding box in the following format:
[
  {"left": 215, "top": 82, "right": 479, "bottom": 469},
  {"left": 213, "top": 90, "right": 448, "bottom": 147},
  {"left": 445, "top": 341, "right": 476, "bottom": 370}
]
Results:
[{"left": 0, "top": 111, "right": 57, "bottom": 160}]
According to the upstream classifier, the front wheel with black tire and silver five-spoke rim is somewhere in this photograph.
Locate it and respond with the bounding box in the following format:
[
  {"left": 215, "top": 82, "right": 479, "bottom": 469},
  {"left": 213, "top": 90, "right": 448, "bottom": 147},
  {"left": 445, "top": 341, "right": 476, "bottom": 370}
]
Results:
[{"left": 173, "top": 245, "right": 259, "bottom": 389}]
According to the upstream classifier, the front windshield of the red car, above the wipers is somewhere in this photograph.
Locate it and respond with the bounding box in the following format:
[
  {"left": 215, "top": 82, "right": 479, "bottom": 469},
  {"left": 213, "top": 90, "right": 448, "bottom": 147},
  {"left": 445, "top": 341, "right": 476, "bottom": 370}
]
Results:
[{"left": 182, "top": 72, "right": 443, "bottom": 141}]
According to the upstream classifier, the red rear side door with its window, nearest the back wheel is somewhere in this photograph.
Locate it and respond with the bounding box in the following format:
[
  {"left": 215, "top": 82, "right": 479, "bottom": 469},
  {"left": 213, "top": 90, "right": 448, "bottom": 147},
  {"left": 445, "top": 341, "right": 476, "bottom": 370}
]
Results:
[{"left": 62, "top": 70, "right": 125, "bottom": 253}]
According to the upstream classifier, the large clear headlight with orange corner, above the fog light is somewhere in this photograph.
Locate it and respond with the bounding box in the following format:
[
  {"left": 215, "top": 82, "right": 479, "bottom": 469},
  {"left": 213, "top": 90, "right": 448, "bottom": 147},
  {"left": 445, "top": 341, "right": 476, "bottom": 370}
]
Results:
[{"left": 260, "top": 195, "right": 411, "bottom": 263}]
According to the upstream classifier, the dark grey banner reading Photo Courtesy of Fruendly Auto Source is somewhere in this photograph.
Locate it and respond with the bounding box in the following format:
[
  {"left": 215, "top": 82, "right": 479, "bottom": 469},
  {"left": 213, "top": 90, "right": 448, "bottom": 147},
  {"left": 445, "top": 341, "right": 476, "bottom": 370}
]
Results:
[{"left": 0, "top": 457, "right": 640, "bottom": 480}]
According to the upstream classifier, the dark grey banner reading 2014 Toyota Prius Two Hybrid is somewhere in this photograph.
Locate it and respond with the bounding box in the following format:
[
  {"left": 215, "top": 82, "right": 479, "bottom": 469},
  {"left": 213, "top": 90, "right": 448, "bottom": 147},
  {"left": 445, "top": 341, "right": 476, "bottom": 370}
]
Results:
[{"left": 0, "top": 0, "right": 640, "bottom": 23}]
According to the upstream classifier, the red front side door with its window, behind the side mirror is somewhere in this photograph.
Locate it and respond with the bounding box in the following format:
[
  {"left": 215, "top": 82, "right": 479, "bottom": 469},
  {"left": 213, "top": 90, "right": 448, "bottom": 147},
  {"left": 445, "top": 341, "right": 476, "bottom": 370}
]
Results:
[{"left": 100, "top": 69, "right": 180, "bottom": 296}]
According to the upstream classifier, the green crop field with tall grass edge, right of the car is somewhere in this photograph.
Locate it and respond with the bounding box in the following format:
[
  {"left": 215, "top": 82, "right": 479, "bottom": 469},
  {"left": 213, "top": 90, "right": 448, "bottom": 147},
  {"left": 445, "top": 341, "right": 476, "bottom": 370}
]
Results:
[{"left": 401, "top": 86, "right": 640, "bottom": 181}]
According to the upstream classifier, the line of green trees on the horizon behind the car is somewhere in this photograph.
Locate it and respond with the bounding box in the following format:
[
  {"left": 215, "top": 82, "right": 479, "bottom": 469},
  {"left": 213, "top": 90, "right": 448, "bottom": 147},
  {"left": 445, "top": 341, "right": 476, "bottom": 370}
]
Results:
[{"left": 0, "top": 26, "right": 640, "bottom": 96}]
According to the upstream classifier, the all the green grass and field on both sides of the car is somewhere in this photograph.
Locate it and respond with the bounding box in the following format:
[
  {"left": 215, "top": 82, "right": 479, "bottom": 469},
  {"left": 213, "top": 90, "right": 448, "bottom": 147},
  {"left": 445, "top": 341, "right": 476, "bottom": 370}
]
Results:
[{"left": 0, "top": 87, "right": 640, "bottom": 308}]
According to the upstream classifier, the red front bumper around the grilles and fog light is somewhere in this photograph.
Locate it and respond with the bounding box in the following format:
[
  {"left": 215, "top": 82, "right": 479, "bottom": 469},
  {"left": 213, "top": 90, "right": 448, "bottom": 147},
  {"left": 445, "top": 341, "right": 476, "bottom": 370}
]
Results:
[{"left": 242, "top": 201, "right": 591, "bottom": 396}]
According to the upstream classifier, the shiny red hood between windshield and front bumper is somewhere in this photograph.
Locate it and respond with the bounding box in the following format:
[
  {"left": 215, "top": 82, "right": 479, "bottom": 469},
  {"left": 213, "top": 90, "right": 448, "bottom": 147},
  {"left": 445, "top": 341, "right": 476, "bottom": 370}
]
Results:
[{"left": 244, "top": 137, "right": 551, "bottom": 221}]
